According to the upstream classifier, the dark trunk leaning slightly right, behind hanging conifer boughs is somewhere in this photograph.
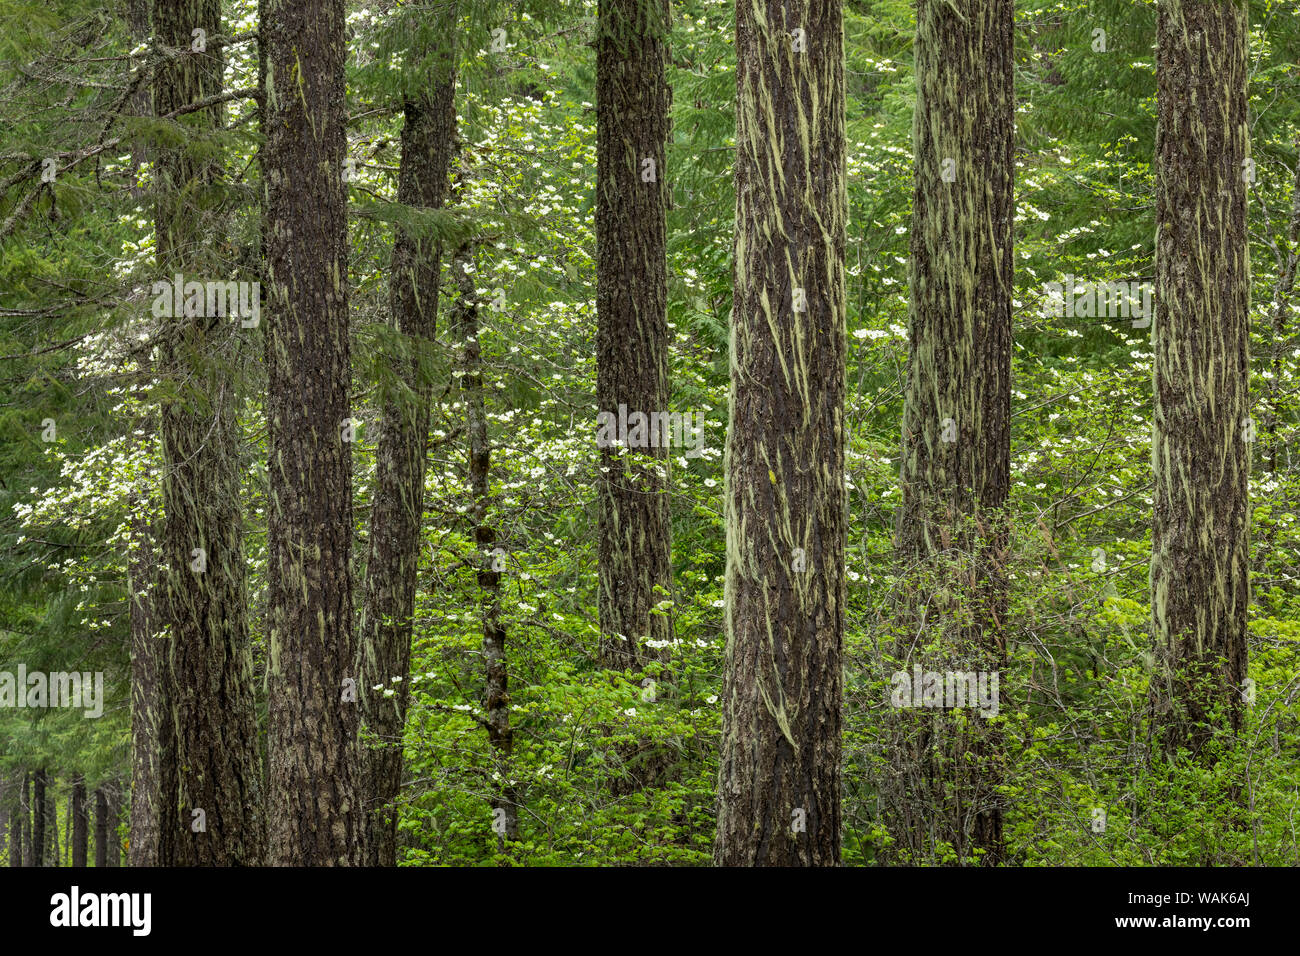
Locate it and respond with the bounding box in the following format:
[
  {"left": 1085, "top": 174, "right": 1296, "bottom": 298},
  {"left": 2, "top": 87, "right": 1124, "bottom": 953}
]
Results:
[{"left": 358, "top": 42, "right": 456, "bottom": 866}]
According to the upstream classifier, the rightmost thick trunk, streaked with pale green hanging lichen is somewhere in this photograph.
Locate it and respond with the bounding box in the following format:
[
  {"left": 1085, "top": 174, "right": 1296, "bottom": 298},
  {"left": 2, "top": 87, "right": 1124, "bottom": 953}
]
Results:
[{"left": 1151, "top": 0, "right": 1253, "bottom": 754}]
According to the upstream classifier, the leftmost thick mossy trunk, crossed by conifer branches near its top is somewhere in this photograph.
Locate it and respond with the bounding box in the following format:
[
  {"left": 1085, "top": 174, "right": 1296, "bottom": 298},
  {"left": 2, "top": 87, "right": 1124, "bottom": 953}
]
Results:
[{"left": 153, "top": 0, "right": 265, "bottom": 866}]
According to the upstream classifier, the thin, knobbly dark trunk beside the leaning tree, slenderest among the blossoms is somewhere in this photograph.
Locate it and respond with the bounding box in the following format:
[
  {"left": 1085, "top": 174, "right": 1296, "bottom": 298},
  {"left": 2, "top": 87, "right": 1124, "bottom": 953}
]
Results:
[{"left": 451, "top": 246, "right": 519, "bottom": 853}]
